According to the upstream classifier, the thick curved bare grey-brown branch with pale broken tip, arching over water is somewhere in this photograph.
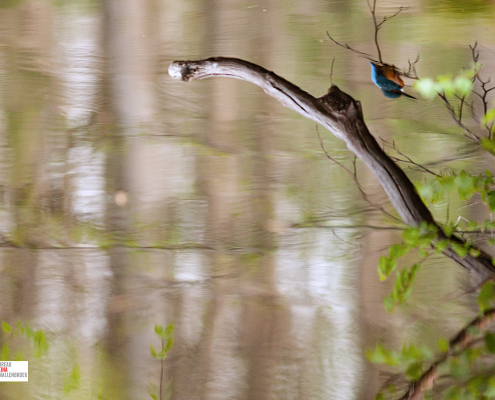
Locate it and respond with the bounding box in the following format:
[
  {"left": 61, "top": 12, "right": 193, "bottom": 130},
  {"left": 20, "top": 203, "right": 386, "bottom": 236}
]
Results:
[{"left": 168, "top": 57, "right": 495, "bottom": 277}]
